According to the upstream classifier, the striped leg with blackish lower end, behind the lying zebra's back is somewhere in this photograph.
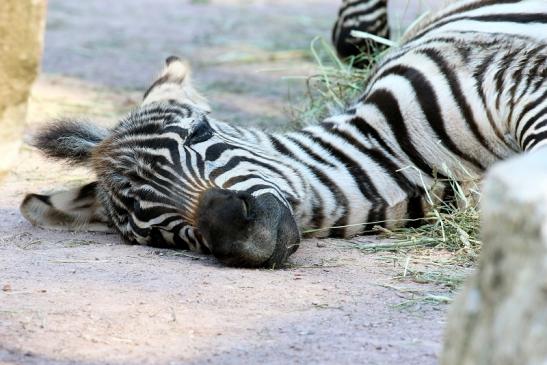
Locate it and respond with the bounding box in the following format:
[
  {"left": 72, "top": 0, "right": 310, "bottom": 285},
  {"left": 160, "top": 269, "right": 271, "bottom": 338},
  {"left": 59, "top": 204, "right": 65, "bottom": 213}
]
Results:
[{"left": 332, "top": 0, "right": 389, "bottom": 67}]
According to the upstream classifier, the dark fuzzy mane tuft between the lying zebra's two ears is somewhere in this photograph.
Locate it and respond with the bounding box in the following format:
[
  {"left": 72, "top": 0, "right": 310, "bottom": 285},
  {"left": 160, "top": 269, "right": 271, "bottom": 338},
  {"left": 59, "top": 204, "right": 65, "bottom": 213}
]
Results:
[{"left": 31, "top": 120, "right": 109, "bottom": 164}]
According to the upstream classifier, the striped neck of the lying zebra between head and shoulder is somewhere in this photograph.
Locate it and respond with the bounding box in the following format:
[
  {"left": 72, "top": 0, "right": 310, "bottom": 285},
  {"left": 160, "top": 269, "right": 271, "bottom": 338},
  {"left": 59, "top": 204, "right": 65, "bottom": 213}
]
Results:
[{"left": 233, "top": 114, "right": 423, "bottom": 237}]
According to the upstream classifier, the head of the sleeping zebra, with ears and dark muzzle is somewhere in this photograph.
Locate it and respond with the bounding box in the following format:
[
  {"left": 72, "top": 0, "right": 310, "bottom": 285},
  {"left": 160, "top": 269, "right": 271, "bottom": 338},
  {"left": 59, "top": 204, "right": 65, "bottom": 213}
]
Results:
[{"left": 21, "top": 57, "right": 300, "bottom": 267}]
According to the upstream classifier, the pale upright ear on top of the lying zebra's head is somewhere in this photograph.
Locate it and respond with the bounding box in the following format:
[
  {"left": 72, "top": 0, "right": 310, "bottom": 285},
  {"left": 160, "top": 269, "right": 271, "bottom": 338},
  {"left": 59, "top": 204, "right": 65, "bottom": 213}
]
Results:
[{"left": 142, "top": 56, "right": 211, "bottom": 113}]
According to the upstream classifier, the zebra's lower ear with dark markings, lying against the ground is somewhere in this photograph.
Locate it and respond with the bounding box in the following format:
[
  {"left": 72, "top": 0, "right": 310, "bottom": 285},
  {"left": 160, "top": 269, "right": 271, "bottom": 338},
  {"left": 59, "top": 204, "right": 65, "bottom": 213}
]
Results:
[{"left": 19, "top": 182, "right": 112, "bottom": 232}]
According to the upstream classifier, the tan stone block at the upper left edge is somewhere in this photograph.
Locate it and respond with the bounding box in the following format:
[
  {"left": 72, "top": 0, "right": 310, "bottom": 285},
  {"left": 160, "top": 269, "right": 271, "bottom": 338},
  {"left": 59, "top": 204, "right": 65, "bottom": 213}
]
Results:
[{"left": 0, "top": 0, "right": 46, "bottom": 179}]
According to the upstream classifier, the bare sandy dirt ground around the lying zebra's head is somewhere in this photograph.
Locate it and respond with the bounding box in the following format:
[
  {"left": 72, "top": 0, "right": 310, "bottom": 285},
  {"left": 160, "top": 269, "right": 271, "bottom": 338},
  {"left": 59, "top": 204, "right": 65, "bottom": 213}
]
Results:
[{"left": 0, "top": 0, "right": 453, "bottom": 365}]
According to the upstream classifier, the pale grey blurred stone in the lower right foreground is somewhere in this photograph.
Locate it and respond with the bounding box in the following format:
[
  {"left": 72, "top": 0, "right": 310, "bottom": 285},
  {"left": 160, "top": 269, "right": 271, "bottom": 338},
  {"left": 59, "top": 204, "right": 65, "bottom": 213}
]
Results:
[{"left": 441, "top": 149, "right": 547, "bottom": 365}]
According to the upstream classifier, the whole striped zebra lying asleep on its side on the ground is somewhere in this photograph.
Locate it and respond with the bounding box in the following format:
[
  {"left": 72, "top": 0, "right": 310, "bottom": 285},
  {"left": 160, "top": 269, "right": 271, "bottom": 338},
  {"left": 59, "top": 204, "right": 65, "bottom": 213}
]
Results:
[{"left": 21, "top": 0, "right": 547, "bottom": 267}]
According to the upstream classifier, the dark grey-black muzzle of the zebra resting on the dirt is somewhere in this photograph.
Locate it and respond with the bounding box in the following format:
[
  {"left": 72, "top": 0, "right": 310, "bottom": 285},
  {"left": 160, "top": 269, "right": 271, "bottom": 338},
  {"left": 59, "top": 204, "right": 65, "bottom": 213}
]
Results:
[{"left": 197, "top": 188, "right": 300, "bottom": 268}]
